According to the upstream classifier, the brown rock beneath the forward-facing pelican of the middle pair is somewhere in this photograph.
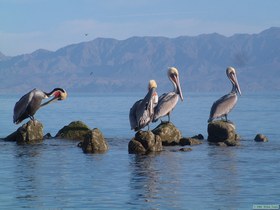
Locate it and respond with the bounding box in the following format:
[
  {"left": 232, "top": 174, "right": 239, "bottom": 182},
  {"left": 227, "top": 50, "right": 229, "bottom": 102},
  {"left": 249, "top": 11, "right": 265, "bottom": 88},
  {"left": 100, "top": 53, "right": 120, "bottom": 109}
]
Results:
[{"left": 128, "top": 130, "right": 162, "bottom": 154}]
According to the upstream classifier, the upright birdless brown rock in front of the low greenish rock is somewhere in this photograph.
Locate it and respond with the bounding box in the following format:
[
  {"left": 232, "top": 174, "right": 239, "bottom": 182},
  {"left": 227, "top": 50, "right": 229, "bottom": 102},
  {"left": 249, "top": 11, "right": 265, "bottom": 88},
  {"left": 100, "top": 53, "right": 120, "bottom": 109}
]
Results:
[{"left": 81, "top": 128, "right": 109, "bottom": 153}]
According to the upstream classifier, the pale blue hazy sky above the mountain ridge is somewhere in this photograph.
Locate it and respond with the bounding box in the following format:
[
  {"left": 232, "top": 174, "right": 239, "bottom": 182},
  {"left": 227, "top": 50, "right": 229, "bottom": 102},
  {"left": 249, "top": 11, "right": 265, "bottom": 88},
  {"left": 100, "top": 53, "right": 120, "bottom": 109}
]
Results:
[{"left": 0, "top": 0, "right": 280, "bottom": 56}]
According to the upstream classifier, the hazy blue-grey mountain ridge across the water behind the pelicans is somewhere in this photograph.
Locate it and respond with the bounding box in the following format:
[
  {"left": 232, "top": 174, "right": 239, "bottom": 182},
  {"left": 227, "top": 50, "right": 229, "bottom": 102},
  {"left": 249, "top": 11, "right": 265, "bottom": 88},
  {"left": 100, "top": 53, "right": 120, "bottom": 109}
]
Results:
[{"left": 0, "top": 27, "right": 280, "bottom": 92}]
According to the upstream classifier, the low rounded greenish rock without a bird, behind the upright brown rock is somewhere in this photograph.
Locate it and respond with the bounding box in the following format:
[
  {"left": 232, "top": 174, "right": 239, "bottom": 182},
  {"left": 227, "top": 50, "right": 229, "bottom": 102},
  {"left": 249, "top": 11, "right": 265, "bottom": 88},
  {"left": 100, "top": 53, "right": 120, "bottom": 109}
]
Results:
[{"left": 55, "top": 121, "right": 91, "bottom": 141}]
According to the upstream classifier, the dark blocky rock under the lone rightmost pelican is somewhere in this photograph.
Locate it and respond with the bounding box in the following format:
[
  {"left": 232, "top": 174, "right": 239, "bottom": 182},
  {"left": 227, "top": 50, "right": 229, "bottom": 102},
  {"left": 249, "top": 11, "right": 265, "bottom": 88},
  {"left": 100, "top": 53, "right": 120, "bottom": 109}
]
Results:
[{"left": 207, "top": 120, "right": 239, "bottom": 146}]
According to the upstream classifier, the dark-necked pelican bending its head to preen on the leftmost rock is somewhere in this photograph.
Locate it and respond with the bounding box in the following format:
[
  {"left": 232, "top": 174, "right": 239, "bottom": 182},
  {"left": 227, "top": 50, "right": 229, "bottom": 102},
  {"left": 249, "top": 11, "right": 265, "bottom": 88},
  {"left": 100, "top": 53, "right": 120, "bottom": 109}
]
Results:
[{"left": 13, "top": 88, "right": 67, "bottom": 124}]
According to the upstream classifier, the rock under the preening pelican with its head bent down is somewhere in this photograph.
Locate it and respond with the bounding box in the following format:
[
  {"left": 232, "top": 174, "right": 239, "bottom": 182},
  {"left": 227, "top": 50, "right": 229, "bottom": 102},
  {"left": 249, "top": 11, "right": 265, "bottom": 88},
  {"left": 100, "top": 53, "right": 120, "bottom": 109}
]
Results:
[{"left": 4, "top": 120, "right": 44, "bottom": 144}]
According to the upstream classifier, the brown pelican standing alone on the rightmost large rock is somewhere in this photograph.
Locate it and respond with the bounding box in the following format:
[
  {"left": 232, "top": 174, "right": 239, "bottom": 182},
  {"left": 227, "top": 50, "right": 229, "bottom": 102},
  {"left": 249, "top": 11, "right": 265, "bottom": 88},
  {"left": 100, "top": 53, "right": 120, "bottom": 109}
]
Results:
[{"left": 208, "top": 67, "right": 241, "bottom": 122}]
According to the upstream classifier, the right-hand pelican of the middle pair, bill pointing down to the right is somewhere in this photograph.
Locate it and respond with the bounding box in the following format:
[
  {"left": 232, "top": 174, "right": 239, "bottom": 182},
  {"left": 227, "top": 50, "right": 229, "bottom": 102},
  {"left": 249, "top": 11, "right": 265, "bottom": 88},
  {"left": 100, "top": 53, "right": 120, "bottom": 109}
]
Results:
[{"left": 153, "top": 67, "right": 183, "bottom": 122}]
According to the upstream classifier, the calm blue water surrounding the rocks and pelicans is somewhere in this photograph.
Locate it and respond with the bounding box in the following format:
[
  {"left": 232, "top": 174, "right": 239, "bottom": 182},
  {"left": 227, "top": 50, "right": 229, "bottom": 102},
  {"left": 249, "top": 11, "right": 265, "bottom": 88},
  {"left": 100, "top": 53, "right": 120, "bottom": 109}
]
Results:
[{"left": 0, "top": 93, "right": 280, "bottom": 209}]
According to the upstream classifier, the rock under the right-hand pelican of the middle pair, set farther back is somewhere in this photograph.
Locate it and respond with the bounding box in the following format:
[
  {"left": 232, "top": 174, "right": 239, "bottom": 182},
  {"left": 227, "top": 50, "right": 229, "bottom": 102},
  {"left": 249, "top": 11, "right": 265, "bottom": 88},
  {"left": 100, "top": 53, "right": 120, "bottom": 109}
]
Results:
[{"left": 152, "top": 122, "right": 182, "bottom": 146}]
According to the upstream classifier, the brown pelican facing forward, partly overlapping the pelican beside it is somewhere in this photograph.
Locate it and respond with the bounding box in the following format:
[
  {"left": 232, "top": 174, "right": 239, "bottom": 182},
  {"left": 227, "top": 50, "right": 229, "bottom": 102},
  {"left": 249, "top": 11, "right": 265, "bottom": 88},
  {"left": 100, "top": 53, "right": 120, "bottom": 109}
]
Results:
[{"left": 129, "top": 80, "right": 158, "bottom": 131}]
